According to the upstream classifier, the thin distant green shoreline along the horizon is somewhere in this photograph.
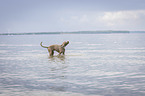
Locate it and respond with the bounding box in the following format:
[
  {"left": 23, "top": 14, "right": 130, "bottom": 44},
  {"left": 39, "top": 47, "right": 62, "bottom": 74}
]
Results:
[{"left": 0, "top": 31, "right": 145, "bottom": 35}]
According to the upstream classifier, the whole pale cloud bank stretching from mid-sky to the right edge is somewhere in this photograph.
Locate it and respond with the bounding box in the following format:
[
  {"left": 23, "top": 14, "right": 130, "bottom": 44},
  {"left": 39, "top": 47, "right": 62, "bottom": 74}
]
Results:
[{"left": 60, "top": 10, "right": 145, "bottom": 30}]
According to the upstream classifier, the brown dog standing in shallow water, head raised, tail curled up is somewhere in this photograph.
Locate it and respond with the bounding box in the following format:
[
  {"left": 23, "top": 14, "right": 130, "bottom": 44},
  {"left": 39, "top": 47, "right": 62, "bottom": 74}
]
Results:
[{"left": 40, "top": 41, "right": 69, "bottom": 56}]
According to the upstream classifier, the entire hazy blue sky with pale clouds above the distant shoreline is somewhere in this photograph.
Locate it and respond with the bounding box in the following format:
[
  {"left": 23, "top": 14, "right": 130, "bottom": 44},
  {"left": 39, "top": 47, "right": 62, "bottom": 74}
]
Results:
[{"left": 0, "top": 0, "right": 145, "bottom": 33}]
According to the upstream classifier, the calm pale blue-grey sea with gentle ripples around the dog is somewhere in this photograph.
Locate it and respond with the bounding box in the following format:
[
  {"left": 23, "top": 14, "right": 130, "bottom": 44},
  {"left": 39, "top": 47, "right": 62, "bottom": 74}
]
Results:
[{"left": 0, "top": 33, "right": 145, "bottom": 96}]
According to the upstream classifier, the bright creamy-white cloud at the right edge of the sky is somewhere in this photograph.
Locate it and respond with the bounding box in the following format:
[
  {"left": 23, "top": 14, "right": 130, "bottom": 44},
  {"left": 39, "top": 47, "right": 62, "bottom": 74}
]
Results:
[{"left": 101, "top": 10, "right": 145, "bottom": 30}]
